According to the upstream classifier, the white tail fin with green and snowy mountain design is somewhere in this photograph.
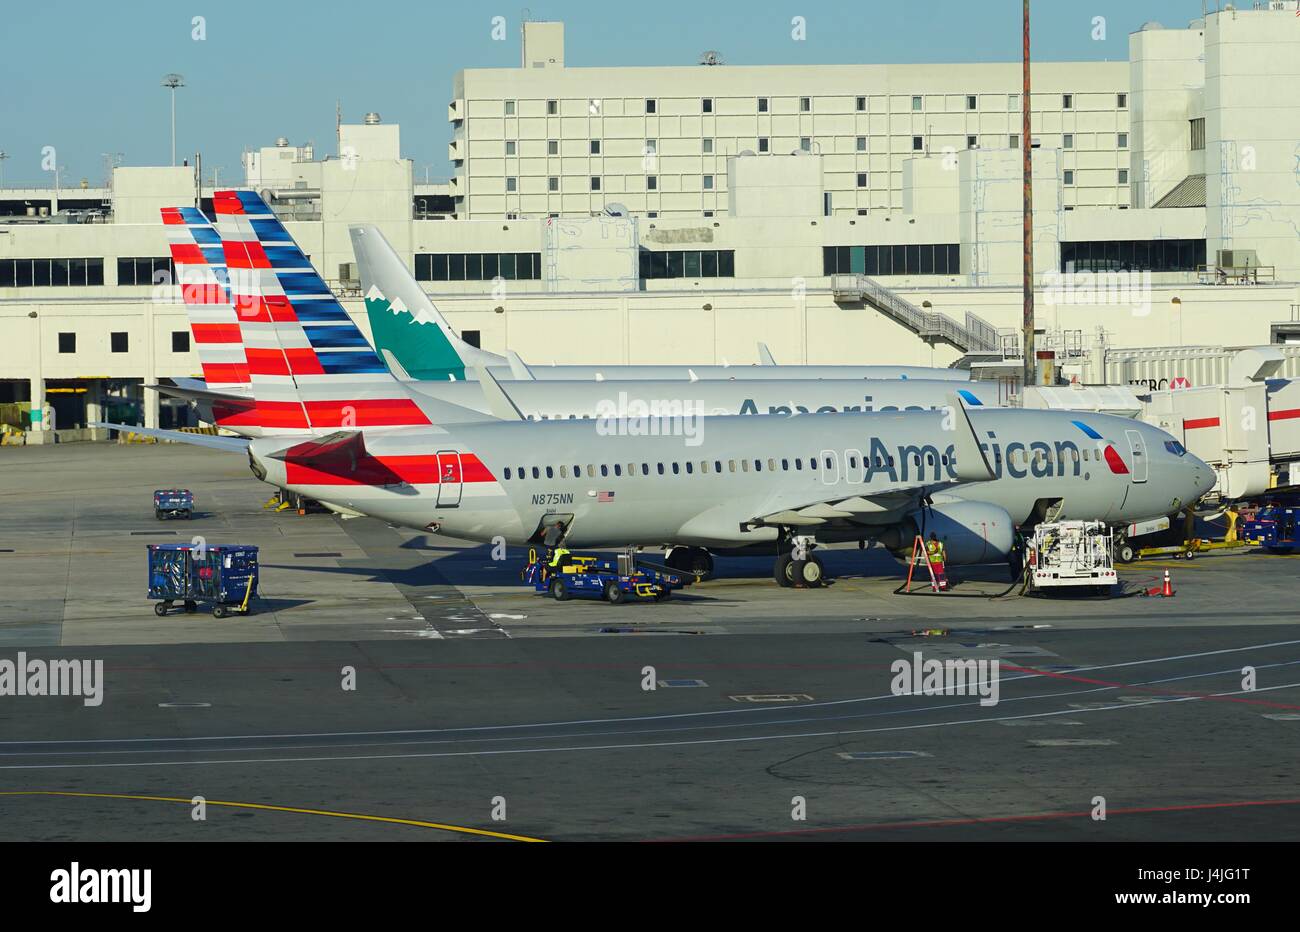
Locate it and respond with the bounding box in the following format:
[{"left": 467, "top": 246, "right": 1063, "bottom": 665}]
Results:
[{"left": 348, "top": 225, "right": 508, "bottom": 381}]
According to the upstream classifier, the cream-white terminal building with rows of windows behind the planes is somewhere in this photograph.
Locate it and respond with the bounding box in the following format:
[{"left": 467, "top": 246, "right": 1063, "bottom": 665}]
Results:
[{"left": 0, "top": 0, "right": 1300, "bottom": 441}]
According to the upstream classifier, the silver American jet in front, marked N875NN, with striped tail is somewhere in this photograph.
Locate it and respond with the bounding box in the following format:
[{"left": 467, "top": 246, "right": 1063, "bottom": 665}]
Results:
[{"left": 105, "top": 198, "right": 1214, "bottom": 586}]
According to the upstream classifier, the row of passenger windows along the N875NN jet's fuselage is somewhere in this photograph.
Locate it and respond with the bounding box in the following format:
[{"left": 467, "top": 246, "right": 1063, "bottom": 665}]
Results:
[{"left": 503, "top": 447, "right": 1102, "bottom": 480}]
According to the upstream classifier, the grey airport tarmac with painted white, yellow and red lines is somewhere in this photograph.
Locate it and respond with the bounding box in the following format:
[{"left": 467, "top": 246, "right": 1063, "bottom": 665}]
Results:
[{"left": 0, "top": 443, "right": 1300, "bottom": 841}]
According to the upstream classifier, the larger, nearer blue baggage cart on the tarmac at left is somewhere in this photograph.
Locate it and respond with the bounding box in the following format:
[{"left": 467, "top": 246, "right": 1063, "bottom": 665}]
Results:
[{"left": 148, "top": 543, "right": 257, "bottom": 619}]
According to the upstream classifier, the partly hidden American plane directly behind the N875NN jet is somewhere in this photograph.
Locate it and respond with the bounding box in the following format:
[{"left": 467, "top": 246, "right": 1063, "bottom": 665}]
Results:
[{"left": 159, "top": 195, "right": 1001, "bottom": 435}]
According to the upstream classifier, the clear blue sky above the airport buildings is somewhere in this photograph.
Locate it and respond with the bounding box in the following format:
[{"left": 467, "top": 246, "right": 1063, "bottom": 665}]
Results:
[{"left": 0, "top": 0, "right": 1214, "bottom": 186}]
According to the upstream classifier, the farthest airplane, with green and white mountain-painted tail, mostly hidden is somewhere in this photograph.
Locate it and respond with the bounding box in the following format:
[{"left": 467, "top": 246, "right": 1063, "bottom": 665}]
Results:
[{"left": 348, "top": 224, "right": 970, "bottom": 382}]
